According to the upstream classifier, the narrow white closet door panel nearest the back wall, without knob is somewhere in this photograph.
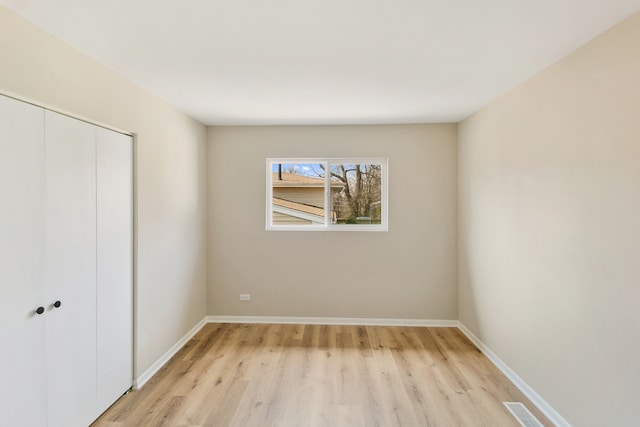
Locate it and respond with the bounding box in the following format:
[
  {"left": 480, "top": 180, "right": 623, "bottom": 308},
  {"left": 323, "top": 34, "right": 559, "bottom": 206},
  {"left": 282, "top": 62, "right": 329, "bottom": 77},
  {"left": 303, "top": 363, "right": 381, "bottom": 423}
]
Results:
[{"left": 96, "top": 128, "right": 133, "bottom": 412}]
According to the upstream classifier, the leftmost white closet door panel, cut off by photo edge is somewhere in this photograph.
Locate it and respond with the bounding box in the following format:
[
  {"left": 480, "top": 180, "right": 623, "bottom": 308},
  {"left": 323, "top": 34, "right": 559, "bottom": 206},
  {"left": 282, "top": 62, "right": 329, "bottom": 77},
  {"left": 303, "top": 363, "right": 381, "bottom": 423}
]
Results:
[{"left": 0, "top": 96, "right": 46, "bottom": 427}]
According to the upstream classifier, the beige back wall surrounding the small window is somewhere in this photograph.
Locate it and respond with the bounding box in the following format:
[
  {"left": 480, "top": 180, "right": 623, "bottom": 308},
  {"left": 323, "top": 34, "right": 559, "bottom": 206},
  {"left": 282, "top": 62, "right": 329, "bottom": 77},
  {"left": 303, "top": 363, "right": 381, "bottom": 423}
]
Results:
[{"left": 208, "top": 125, "right": 457, "bottom": 319}]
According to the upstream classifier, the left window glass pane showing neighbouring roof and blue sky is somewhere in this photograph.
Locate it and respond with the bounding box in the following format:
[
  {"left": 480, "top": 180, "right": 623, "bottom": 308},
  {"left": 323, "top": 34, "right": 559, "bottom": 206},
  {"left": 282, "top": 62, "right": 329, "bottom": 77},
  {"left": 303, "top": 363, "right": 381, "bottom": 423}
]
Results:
[{"left": 271, "top": 163, "right": 326, "bottom": 226}]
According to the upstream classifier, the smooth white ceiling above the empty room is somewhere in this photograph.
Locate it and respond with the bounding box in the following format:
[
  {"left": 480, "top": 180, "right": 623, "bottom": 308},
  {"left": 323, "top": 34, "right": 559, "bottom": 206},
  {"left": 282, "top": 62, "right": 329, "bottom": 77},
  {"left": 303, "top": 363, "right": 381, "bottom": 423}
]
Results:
[{"left": 0, "top": 0, "right": 640, "bottom": 125}]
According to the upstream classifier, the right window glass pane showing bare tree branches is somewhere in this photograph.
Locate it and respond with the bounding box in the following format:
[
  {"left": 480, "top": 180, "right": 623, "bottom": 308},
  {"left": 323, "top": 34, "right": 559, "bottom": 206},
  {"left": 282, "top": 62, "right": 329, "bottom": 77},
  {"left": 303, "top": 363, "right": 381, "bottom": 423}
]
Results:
[{"left": 330, "top": 163, "right": 383, "bottom": 224}]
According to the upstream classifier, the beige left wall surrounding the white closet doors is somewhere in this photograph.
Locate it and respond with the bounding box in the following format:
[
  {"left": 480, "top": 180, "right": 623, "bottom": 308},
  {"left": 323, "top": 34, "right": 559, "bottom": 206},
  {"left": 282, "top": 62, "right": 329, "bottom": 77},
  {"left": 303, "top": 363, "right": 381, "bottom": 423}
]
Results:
[{"left": 0, "top": 7, "right": 206, "bottom": 375}]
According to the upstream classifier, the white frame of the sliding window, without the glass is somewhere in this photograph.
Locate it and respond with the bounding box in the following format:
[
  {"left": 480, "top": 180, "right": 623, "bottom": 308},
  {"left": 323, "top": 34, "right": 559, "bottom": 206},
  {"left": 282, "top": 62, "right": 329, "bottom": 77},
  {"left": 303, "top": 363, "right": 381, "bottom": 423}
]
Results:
[{"left": 266, "top": 157, "right": 389, "bottom": 231}]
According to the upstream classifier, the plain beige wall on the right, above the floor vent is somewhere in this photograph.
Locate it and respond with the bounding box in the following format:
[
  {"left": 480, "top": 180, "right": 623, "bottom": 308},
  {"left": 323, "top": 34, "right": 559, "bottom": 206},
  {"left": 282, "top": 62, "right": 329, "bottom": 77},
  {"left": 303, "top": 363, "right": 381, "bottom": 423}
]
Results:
[{"left": 459, "top": 10, "right": 640, "bottom": 426}]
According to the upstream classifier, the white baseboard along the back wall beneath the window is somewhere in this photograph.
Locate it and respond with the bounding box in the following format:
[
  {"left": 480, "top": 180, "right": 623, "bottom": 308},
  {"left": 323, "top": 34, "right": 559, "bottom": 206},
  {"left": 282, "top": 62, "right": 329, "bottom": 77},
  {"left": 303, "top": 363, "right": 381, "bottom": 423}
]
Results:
[{"left": 206, "top": 316, "right": 459, "bottom": 327}]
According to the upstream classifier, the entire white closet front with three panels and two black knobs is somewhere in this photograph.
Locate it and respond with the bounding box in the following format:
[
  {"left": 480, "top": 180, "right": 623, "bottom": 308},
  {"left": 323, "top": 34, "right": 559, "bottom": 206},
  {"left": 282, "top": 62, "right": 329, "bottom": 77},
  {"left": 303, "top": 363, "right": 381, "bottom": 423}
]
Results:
[{"left": 0, "top": 96, "right": 133, "bottom": 427}]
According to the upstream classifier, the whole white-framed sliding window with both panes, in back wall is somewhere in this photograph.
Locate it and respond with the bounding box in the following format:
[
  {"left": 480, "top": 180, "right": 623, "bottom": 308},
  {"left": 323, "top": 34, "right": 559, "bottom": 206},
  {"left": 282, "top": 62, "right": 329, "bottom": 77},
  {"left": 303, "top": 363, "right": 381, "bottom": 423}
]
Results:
[{"left": 266, "top": 158, "right": 387, "bottom": 231}]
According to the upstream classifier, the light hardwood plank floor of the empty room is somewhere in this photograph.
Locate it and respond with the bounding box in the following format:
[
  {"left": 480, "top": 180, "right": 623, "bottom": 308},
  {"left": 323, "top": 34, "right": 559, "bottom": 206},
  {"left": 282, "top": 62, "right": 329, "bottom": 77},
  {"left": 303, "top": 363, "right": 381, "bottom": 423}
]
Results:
[{"left": 94, "top": 324, "right": 552, "bottom": 427}]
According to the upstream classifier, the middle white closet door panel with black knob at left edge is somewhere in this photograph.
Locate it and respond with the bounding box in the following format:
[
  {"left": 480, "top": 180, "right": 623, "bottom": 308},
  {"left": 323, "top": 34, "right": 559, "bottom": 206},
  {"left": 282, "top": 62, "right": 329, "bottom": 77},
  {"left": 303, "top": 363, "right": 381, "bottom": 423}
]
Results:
[{"left": 45, "top": 111, "right": 96, "bottom": 427}]
